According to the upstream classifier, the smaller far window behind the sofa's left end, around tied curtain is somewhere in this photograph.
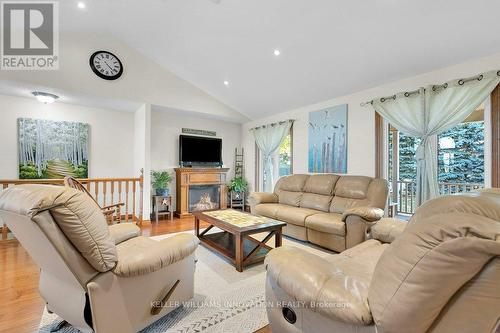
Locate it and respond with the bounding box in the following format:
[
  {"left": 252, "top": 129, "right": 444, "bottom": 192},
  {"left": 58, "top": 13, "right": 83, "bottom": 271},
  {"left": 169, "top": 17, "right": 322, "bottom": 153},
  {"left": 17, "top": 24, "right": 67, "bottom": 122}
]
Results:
[{"left": 255, "top": 128, "right": 293, "bottom": 191}]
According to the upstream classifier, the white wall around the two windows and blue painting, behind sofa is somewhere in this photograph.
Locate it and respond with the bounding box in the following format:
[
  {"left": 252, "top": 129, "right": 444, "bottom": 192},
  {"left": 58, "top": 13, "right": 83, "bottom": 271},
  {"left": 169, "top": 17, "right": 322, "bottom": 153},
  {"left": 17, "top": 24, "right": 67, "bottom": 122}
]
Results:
[{"left": 242, "top": 54, "right": 500, "bottom": 189}]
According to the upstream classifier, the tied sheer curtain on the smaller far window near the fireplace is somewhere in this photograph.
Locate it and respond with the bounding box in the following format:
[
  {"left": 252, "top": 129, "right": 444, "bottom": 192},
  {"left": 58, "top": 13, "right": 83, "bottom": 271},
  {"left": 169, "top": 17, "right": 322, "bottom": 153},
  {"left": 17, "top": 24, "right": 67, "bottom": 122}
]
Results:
[{"left": 250, "top": 120, "right": 293, "bottom": 192}]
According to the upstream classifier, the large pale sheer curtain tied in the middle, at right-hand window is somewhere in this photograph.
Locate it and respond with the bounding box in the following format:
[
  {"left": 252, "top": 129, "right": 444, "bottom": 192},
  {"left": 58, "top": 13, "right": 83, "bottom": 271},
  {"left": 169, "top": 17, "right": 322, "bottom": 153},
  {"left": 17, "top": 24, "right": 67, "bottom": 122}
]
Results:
[{"left": 372, "top": 71, "right": 500, "bottom": 206}]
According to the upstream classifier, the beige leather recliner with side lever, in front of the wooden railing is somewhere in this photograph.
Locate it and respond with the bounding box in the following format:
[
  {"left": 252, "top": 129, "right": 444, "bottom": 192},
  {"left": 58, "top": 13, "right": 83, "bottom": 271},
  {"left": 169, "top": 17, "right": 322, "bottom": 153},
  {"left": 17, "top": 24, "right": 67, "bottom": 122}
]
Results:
[{"left": 0, "top": 185, "right": 198, "bottom": 333}]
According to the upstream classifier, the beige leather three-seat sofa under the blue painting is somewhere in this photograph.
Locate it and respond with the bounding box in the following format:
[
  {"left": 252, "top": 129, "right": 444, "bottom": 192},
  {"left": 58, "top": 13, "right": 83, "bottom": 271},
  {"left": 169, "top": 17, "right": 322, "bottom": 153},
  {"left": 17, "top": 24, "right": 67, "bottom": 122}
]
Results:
[{"left": 248, "top": 174, "right": 388, "bottom": 252}]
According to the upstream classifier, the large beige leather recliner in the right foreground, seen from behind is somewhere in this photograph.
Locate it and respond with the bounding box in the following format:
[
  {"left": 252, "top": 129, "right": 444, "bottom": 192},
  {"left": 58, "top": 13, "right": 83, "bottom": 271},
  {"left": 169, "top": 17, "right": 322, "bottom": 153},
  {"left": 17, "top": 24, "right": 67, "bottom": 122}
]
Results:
[{"left": 266, "top": 190, "right": 500, "bottom": 333}]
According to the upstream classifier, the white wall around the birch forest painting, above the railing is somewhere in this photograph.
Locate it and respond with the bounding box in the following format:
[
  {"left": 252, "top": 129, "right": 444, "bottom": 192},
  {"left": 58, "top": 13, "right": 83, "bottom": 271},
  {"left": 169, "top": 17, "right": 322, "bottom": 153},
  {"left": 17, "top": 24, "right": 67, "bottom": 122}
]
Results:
[{"left": 0, "top": 95, "right": 139, "bottom": 179}]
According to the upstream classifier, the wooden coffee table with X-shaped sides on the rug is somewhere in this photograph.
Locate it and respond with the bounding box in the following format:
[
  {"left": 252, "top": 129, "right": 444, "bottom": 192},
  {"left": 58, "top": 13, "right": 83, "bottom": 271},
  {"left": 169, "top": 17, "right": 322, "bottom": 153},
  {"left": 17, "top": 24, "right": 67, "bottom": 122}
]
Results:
[{"left": 193, "top": 209, "right": 286, "bottom": 272}]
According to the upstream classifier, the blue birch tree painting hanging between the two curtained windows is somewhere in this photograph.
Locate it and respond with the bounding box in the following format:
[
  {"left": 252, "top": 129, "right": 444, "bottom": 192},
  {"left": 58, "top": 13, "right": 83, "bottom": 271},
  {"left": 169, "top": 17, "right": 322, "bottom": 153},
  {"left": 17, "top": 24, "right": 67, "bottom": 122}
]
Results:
[{"left": 309, "top": 104, "right": 347, "bottom": 173}]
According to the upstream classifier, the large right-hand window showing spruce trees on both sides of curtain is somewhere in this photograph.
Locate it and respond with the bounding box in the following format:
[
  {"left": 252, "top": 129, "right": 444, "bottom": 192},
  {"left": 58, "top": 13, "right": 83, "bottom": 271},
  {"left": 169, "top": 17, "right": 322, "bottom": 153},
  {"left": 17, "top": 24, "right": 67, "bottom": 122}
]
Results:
[{"left": 387, "top": 106, "right": 485, "bottom": 214}]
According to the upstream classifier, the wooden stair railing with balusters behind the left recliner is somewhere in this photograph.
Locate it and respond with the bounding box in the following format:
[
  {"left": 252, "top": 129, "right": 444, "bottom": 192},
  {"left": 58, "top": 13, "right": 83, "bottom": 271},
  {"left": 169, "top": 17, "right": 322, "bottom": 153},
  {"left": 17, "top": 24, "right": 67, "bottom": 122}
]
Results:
[{"left": 0, "top": 175, "right": 143, "bottom": 239}]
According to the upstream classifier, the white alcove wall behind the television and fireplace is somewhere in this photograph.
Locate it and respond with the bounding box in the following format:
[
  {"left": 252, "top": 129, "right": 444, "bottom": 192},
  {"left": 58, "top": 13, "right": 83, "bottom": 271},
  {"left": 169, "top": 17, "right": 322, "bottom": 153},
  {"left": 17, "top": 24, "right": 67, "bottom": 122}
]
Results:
[{"left": 151, "top": 108, "right": 243, "bottom": 209}]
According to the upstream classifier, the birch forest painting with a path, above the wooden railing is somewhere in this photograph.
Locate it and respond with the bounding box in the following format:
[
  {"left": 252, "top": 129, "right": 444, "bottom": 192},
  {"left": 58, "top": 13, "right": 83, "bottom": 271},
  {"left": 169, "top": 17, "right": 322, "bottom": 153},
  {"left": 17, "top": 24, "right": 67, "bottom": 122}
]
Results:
[{"left": 18, "top": 118, "right": 89, "bottom": 179}]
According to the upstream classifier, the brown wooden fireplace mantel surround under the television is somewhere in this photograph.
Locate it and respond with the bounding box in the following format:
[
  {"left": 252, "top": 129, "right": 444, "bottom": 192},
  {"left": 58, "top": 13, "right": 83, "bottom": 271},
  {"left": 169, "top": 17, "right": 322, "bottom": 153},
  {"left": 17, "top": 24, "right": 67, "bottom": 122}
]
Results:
[{"left": 174, "top": 168, "right": 229, "bottom": 217}]
